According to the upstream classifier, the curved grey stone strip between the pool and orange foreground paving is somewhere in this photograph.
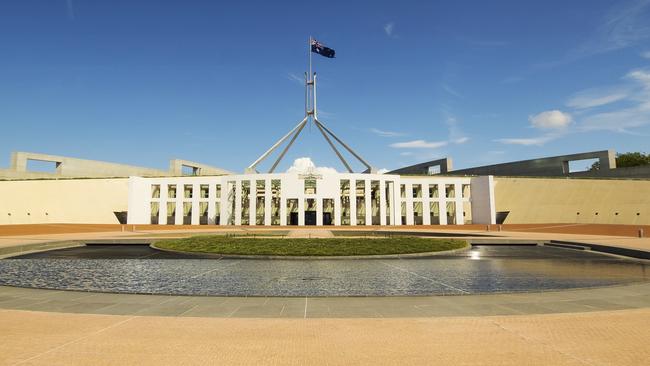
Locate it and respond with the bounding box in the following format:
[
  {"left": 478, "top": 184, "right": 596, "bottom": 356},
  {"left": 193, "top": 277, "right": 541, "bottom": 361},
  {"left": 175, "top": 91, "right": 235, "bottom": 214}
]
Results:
[{"left": 0, "top": 282, "right": 650, "bottom": 318}]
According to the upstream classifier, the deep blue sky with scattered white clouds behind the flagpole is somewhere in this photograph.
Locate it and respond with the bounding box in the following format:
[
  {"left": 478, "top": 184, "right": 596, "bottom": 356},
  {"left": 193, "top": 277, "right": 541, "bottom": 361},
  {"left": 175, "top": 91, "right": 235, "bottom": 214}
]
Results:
[{"left": 0, "top": 0, "right": 650, "bottom": 171}]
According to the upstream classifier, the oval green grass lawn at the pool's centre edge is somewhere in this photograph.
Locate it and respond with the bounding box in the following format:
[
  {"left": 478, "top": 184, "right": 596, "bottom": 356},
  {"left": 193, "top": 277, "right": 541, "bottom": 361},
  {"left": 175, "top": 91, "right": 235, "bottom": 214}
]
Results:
[{"left": 154, "top": 235, "right": 467, "bottom": 256}]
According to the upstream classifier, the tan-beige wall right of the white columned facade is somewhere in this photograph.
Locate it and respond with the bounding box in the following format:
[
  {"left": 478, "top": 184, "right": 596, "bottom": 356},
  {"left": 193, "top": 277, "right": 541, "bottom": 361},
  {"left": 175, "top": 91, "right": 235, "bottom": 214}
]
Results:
[{"left": 494, "top": 177, "right": 650, "bottom": 225}]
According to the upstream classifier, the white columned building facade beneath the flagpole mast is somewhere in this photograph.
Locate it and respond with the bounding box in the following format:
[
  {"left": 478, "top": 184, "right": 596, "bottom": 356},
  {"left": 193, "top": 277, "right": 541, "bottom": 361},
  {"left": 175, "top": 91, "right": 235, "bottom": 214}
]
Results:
[{"left": 128, "top": 173, "right": 495, "bottom": 226}]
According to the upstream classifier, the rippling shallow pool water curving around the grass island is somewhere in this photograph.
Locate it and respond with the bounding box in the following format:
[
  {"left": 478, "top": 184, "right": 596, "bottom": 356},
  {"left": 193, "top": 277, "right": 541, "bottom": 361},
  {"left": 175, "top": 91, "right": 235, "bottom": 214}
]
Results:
[{"left": 0, "top": 245, "right": 650, "bottom": 296}]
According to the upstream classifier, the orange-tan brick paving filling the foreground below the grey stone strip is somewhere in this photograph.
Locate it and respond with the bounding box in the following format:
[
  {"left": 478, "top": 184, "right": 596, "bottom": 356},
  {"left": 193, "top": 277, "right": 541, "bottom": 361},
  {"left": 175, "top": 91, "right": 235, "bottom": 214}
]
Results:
[{"left": 0, "top": 309, "right": 650, "bottom": 366}]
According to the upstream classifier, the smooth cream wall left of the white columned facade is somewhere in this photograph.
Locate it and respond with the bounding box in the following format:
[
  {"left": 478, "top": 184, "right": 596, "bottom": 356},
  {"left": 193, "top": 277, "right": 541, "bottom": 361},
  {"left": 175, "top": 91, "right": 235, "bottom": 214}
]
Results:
[{"left": 0, "top": 178, "right": 128, "bottom": 225}]
